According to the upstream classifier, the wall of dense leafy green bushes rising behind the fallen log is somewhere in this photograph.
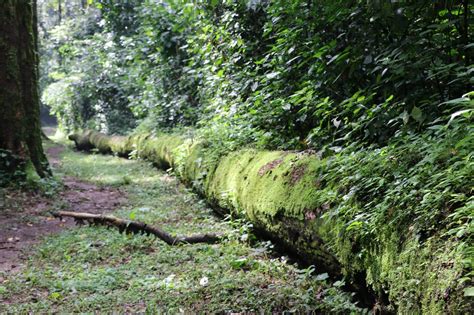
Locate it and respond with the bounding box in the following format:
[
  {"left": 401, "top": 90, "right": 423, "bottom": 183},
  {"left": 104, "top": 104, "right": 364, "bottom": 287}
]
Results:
[{"left": 39, "top": 0, "right": 474, "bottom": 148}]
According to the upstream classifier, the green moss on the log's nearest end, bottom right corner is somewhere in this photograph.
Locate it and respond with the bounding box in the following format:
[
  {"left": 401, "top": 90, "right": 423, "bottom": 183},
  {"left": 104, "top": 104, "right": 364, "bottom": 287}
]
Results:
[{"left": 380, "top": 236, "right": 469, "bottom": 314}]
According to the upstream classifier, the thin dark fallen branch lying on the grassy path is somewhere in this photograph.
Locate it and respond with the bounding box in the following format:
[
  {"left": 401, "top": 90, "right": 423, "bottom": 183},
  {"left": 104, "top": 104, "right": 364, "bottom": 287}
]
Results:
[{"left": 53, "top": 211, "right": 222, "bottom": 245}]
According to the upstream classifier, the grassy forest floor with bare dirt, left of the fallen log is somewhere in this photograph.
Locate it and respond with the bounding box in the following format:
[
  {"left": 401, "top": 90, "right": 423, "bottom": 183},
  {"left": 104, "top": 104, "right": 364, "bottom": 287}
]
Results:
[{"left": 0, "top": 133, "right": 361, "bottom": 313}]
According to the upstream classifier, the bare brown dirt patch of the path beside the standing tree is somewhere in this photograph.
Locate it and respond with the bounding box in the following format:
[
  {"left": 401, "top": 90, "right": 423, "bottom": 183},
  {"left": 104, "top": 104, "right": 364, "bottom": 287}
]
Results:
[{"left": 0, "top": 145, "right": 126, "bottom": 272}]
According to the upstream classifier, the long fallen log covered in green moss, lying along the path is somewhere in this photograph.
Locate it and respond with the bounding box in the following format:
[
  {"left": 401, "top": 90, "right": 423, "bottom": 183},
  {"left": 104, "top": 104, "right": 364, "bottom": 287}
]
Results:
[{"left": 70, "top": 131, "right": 472, "bottom": 314}]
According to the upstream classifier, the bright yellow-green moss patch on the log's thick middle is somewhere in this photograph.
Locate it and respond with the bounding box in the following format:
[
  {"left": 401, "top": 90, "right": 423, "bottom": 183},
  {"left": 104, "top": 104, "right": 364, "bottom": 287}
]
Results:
[{"left": 209, "top": 150, "right": 334, "bottom": 224}]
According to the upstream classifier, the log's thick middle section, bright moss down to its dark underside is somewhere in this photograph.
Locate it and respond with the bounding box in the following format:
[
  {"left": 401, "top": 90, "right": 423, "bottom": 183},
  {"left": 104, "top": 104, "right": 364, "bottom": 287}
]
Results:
[{"left": 203, "top": 150, "right": 340, "bottom": 275}]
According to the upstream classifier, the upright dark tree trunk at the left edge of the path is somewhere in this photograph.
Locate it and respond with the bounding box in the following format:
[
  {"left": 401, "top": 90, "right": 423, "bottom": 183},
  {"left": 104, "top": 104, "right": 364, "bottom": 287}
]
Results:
[{"left": 0, "top": 0, "right": 50, "bottom": 183}]
